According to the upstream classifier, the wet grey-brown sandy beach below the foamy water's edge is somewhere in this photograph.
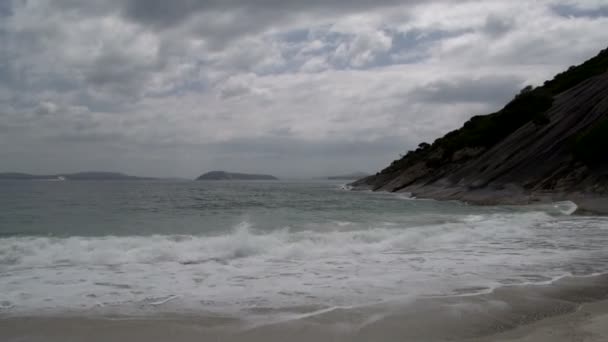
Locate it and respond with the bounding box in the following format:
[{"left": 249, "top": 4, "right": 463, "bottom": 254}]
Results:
[{"left": 0, "top": 274, "right": 608, "bottom": 342}]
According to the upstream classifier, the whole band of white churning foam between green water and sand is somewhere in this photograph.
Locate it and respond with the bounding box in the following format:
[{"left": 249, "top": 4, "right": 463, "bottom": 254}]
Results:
[{"left": 0, "top": 211, "right": 606, "bottom": 320}]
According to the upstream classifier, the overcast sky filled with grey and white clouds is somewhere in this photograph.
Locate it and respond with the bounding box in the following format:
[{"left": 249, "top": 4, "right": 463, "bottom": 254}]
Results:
[{"left": 0, "top": 0, "right": 608, "bottom": 178}]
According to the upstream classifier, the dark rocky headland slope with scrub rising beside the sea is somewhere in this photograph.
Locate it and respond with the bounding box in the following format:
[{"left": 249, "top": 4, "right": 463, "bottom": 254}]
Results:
[{"left": 351, "top": 49, "right": 608, "bottom": 214}]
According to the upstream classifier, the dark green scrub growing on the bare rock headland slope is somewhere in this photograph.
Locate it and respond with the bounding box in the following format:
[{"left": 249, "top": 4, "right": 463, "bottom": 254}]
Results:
[{"left": 380, "top": 49, "right": 608, "bottom": 174}]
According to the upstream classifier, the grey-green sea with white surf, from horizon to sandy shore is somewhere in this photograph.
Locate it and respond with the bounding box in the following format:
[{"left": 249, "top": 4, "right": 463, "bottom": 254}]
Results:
[{"left": 0, "top": 181, "right": 608, "bottom": 338}]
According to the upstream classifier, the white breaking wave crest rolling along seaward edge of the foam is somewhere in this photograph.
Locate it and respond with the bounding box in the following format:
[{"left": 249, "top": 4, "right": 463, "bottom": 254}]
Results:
[{"left": 0, "top": 212, "right": 551, "bottom": 268}]
